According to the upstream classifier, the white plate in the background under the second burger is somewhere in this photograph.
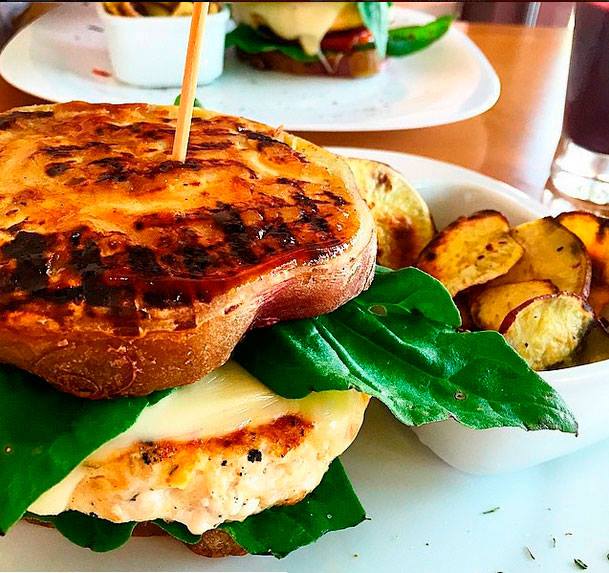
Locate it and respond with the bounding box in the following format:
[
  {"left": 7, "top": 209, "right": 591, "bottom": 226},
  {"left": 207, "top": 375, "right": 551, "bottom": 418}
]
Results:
[{"left": 0, "top": 3, "right": 499, "bottom": 131}]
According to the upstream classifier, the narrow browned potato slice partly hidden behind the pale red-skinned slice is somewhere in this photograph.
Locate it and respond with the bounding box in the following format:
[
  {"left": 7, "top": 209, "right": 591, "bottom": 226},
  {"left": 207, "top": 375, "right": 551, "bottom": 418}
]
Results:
[{"left": 470, "top": 279, "right": 558, "bottom": 330}]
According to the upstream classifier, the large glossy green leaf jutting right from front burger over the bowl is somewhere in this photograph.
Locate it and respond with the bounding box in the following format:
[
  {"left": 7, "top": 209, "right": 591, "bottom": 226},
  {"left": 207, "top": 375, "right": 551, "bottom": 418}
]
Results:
[{"left": 235, "top": 268, "right": 577, "bottom": 432}]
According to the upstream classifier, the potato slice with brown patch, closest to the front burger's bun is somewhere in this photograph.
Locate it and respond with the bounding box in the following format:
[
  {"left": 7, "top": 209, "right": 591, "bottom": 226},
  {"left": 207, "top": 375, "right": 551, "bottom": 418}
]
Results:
[{"left": 347, "top": 158, "right": 436, "bottom": 269}]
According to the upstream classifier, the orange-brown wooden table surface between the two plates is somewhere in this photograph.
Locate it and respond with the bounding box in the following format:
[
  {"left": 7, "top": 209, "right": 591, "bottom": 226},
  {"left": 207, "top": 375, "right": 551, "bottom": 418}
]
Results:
[{"left": 0, "top": 24, "right": 571, "bottom": 198}]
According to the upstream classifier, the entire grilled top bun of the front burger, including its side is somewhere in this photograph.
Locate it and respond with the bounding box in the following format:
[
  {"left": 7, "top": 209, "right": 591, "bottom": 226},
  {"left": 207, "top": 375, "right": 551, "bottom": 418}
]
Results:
[{"left": 0, "top": 102, "right": 376, "bottom": 398}]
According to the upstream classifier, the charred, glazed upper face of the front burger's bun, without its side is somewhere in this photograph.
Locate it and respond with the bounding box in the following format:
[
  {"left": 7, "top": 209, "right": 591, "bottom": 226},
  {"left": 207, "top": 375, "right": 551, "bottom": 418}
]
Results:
[{"left": 0, "top": 102, "right": 360, "bottom": 334}]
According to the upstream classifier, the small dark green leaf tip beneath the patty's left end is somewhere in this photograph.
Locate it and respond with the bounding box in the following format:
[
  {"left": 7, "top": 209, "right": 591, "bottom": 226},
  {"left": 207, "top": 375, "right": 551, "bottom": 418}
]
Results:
[{"left": 28, "top": 511, "right": 136, "bottom": 553}]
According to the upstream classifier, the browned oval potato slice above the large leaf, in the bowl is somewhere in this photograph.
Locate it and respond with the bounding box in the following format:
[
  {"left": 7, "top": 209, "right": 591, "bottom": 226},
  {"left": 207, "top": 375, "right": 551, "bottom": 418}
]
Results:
[{"left": 417, "top": 210, "right": 524, "bottom": 296}]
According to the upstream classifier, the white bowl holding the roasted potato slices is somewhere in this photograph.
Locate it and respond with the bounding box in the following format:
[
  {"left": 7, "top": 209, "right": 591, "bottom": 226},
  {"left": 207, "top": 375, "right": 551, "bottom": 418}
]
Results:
[{"left": 333, "top": 148, "right": 609, "bottom": 474}]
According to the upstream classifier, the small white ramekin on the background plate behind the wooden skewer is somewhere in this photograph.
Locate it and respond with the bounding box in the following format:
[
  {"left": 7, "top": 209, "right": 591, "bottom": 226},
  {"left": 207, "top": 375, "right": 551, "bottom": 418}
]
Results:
[{"left": 96, "top": 2, "right": 229, "bottom": 88}]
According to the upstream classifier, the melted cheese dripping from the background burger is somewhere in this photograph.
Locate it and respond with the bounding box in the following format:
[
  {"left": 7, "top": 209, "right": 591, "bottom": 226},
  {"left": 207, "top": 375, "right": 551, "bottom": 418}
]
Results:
[{"left": 231, "top": 2, "right": 362, "bottom": 56}]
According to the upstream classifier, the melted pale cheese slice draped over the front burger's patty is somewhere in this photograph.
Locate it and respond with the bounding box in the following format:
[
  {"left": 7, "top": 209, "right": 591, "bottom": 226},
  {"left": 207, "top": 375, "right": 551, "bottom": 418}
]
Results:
[{"left": 29, "top": 362, "right": 362, "bottom": 515}]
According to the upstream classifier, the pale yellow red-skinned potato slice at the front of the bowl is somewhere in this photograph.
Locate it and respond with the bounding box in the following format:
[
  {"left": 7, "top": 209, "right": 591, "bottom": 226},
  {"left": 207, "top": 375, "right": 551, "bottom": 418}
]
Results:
[{"left": 499, "top": 292, "right": 595, "bottom": 370}]
